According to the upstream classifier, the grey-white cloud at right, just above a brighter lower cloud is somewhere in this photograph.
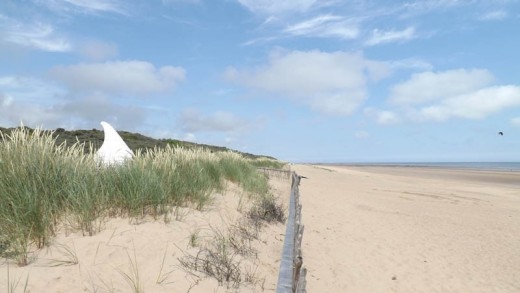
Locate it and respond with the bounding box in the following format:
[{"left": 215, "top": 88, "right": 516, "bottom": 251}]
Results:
[{"left": 390, "top": 69, "right": 494, "bottom": 105}]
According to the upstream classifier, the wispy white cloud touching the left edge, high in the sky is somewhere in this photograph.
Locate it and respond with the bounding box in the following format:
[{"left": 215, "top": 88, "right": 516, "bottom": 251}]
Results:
[{"left": 0, "top": 18, "right": 72, "bottom": 52}]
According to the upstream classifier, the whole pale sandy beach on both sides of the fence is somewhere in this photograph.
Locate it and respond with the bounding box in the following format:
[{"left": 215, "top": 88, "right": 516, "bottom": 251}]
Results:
[{"left": 4, "top": 165, "right": 520, "bottom": 292}]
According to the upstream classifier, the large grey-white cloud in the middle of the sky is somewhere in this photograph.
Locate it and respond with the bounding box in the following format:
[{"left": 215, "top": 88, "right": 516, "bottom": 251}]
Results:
[{"left": 226, "top": 51, "right": 389, "bottom": 115}]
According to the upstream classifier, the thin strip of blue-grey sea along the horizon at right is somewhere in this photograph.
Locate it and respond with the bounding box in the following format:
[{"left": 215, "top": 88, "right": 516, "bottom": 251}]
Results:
[{"left": 332, "top": 162, "right": 520, "bottom": 172}]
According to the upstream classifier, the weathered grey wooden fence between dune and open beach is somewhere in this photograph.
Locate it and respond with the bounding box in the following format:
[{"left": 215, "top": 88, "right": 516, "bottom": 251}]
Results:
[{"left": 276, "top": 172, "right": 307, "bottom": 293}]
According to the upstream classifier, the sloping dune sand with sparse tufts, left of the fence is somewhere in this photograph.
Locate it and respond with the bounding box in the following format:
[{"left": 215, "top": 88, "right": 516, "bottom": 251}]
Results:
[{"left": 0, "top": 179, "right": 290, "bottom": 293}]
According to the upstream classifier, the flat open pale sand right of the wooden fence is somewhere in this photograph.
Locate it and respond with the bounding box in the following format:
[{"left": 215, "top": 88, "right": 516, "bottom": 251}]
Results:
[{"left": 293, "top": 165, "right": 520, "bottom": 292}]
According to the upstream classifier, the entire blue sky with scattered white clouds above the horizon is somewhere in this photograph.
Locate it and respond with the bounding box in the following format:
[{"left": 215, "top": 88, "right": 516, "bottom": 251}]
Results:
[{"left": 0, "top": 0, "right": 520, "bottom": 163}]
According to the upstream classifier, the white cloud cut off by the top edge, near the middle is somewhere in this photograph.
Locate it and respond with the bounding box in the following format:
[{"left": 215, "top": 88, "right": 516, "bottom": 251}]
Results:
[{"left": 238, "top": 0, "right": 318, "bottom": 14}]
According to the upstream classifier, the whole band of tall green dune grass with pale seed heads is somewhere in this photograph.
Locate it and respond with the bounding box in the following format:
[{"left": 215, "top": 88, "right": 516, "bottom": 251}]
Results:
[{"left": 0, "top": 128, "right": 284, "bottom": 265}]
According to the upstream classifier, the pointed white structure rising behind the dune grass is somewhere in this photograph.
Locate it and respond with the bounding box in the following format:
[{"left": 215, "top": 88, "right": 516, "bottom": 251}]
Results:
[{"left": 96, "top": 121, "right": 134, "bottom": 166}]
